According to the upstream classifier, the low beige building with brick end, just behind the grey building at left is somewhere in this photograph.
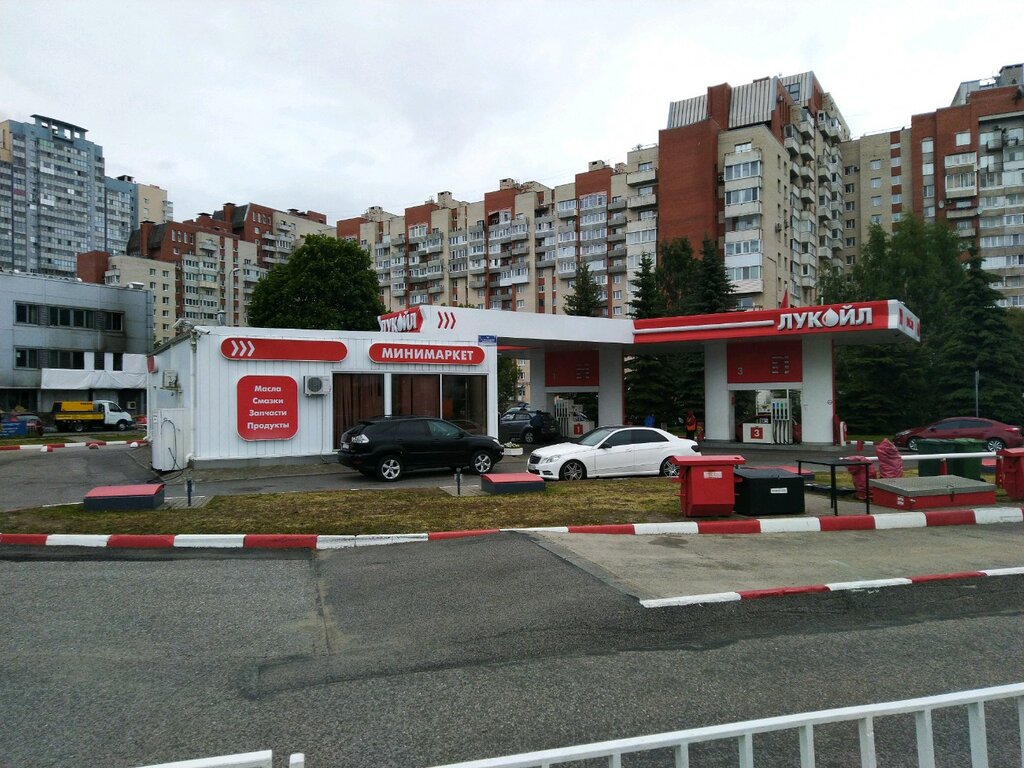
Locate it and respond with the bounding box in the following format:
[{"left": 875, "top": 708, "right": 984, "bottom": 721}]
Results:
[{"left": 78, "top": 251, "right": 177, "bottom": 345}]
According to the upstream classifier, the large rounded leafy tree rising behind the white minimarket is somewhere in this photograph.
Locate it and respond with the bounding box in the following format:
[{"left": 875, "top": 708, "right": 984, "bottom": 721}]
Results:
[{"left": 247, "top": 234, "right": 384, "bottom": 331}]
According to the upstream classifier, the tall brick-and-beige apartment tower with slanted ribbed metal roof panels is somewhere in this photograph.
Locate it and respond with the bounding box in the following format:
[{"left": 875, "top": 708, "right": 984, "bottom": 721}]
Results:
[{"left": 658, "top": 72, "right": 849, "bottom": 308}]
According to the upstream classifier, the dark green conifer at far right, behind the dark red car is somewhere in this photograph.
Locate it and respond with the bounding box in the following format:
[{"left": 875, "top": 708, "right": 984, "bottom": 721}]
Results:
[{"left": 935, "top": 254, "right": 1024, "bottom": 424}]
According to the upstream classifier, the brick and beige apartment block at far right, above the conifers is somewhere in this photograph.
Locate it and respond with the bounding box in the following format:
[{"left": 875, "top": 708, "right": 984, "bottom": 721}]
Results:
[{"left": 843, "top": 65, "right": 1024, "bottom": 307}]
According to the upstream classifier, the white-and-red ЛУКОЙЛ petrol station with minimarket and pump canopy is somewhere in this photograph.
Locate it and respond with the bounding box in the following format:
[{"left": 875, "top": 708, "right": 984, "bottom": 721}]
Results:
[{"left": 147, "top": 300, "right": 921, "bottom": 471}]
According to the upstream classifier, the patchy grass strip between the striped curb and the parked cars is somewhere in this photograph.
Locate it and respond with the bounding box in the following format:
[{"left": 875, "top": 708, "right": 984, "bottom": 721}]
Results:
[{"left": 0, "top": 477, "right": 682, "bottom": 535}]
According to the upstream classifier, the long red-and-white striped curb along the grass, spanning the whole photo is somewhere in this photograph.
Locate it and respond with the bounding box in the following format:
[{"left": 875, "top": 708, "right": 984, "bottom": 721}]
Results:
[{"left": 0, "top": 507, "right": 1024, "bottom": 549}]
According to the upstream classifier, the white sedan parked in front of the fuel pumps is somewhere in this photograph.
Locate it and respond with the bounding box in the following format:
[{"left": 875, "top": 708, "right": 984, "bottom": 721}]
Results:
[{"left": 526, "top": 427, "right": 700, "bottom": 480}]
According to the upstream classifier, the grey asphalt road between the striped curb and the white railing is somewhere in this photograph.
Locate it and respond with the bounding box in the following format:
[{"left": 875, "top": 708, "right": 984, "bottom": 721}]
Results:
[{"left": 0, "top": 525, "right": 1024, "bottom": 768}]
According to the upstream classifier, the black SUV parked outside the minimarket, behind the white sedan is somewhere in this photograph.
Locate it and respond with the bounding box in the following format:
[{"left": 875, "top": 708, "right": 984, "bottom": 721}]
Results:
[{"left": 338, "top": 416, "right": 504, "bottom": 482}]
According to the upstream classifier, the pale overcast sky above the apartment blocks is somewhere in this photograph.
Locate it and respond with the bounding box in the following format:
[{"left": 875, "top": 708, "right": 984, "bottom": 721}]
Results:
[{"left": 0, "top": 0, "right": 1024, "bottom": 223}]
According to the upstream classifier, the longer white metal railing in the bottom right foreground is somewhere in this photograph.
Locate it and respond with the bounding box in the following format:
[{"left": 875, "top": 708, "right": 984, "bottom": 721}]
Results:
[{"left": 423, "top": 683, "right": 1024, "bottom": 768}]
